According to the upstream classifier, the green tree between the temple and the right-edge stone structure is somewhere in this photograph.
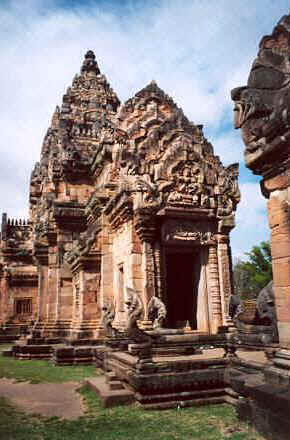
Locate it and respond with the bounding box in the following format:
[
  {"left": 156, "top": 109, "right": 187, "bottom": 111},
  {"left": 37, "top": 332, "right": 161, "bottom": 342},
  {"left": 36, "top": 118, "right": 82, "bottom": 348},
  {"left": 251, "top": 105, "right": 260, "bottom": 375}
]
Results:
[{"left": 233, "top": 241, "right": 273, "bottom": 299}]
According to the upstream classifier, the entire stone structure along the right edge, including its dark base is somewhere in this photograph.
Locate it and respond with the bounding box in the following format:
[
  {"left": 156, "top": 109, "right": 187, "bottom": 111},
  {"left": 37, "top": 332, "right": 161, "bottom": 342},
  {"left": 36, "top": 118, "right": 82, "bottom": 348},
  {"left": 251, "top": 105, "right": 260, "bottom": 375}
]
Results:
[{"left": 232, "top": 14, "right": 290, "bottom": 440}]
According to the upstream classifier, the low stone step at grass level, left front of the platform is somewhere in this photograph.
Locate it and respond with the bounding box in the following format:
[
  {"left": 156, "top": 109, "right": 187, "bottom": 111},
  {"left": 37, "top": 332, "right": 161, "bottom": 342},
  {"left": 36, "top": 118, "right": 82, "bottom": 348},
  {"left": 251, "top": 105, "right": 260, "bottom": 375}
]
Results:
[{"left": 85, "top": 376, "right": 135, "bottom": 408}]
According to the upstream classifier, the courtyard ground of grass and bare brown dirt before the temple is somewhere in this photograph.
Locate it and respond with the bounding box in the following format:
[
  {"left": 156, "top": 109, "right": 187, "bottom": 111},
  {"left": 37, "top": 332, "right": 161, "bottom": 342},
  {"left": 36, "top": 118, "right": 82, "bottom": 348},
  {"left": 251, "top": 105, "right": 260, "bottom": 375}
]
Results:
[{"left": 0, "top": 346, "right": 265, "bottom": 440}]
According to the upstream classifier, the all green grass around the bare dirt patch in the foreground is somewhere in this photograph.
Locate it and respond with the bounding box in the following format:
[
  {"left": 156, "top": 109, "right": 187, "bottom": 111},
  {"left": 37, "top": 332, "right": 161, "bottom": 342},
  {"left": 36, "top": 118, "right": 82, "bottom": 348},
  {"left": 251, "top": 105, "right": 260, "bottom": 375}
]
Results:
[{"left": 0, "top": 356, "right": 263, "bottom": 440}]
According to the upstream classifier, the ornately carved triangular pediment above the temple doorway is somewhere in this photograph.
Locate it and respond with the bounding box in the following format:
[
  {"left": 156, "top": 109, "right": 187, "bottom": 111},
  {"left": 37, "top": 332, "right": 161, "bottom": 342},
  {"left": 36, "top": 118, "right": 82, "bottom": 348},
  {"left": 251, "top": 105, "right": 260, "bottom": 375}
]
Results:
[{"left": 99, "top": 83, "right": 240, "bottom": 222}]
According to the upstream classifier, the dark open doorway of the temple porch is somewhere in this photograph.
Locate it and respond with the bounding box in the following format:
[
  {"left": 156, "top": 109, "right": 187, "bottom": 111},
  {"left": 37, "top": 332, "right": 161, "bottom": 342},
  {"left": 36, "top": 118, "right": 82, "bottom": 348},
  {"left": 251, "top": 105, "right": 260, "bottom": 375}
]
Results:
[{"left": 166, "top": 251, "right": 197, "bottom": 329}]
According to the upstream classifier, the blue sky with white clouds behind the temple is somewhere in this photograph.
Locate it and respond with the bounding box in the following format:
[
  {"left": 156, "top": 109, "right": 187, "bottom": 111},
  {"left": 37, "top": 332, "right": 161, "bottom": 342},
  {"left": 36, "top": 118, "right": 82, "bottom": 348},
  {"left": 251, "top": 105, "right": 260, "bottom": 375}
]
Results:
[{"left": 0, "top": 0, "right": 290, "bottom": 257}]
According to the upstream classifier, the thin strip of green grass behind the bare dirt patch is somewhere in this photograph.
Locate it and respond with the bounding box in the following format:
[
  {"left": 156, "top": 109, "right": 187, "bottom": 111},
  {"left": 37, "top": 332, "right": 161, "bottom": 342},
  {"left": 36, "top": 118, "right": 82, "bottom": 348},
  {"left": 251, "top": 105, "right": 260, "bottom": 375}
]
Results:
[{"left": 0, "top": 355, "right": 97, "bottom": 384}]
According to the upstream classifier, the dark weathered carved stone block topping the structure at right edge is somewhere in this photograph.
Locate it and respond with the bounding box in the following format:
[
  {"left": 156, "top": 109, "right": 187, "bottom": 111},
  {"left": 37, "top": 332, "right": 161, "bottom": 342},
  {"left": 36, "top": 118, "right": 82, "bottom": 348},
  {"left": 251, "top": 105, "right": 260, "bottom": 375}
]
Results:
[{"left": 232, "top": 15, "right": 290, "bottom": 174}]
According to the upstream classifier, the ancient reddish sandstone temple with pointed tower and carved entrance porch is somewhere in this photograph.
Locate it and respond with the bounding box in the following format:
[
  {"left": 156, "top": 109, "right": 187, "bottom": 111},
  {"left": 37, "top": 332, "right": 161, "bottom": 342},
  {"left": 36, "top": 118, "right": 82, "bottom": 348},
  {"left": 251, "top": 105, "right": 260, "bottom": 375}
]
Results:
[{"left": 0, "top": 51, "right": 239, "bottom": 338}]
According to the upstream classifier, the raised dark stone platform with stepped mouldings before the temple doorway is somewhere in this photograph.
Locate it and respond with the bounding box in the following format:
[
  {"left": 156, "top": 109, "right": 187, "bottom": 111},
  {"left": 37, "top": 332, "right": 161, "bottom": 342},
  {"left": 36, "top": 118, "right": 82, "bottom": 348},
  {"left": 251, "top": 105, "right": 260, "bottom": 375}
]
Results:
[{"left": 88, "top": 349, "right": 267, "bottom": 409}]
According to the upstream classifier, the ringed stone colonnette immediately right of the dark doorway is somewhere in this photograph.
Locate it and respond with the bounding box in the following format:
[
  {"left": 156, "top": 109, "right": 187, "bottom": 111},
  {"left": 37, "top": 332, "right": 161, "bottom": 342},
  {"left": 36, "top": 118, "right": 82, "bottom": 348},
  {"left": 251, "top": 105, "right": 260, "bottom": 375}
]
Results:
[{"left": 208, "top": 246, "right": 222, "bottom": 334}]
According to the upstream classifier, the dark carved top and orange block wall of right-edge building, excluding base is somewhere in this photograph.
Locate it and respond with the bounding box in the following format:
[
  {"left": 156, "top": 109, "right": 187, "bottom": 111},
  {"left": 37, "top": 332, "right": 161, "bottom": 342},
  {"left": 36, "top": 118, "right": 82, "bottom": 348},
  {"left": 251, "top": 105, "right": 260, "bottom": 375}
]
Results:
[{"left": 232, "top": 11, "right": 290, "bottom": 350}]
